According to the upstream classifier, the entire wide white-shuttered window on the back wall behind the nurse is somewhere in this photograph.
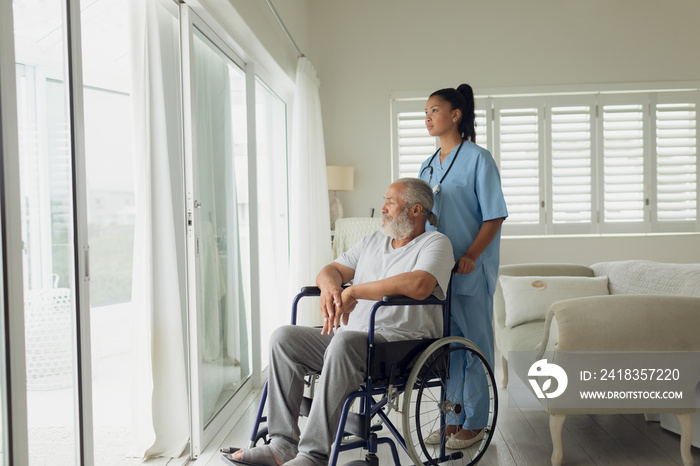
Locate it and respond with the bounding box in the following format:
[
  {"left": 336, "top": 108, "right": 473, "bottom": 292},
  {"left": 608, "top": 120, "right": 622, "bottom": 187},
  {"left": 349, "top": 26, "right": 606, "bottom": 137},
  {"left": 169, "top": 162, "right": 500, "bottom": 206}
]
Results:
[{"left": 392, "top": 86, "right": 700, "bottom": 235}]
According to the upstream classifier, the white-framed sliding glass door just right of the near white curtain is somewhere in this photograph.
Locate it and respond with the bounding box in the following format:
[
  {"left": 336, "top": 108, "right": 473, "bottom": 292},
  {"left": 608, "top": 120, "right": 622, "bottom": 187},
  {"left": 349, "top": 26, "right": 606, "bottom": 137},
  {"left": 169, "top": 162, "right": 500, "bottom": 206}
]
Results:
[{"left": 182, "top": 8, "right": 251, "bottom": 456}]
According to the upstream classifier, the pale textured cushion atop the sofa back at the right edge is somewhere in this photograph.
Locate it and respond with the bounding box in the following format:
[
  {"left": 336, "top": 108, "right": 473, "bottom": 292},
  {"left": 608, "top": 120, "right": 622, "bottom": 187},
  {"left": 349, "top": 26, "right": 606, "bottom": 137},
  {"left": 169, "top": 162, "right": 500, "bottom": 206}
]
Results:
[{"left": 591, "top": 260, "right": 700, "bottom": 297}]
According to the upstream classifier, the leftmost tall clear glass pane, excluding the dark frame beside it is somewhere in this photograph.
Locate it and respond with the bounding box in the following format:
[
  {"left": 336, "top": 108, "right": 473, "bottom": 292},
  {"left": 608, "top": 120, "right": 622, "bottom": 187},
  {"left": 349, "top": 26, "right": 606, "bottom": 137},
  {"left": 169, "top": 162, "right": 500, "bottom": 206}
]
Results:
[{"left": 13, "top": 0, "right": 79, "bottom": 465}]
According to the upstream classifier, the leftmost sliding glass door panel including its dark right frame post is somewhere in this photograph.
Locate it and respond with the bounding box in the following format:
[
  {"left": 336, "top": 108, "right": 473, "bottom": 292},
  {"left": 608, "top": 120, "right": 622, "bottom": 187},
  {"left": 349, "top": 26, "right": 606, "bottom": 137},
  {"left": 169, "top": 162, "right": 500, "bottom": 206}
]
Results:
[{"left": 13, "top": 0, "right": 92, "bottom": 465}]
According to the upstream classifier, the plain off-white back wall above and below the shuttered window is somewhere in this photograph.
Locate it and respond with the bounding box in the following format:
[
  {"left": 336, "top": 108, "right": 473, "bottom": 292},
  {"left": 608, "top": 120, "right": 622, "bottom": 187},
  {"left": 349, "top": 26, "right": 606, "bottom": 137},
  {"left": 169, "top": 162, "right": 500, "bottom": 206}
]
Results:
[{"left": 306, "top": 0, "right": 700, "bottom": 264}]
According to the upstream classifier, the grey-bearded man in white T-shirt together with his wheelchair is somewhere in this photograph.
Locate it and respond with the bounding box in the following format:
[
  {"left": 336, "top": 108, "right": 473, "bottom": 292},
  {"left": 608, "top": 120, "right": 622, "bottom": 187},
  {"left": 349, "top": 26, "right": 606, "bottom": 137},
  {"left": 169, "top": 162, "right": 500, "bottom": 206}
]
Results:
[{"left": 223, "top": 178, "right": 495, "bottom": 466}]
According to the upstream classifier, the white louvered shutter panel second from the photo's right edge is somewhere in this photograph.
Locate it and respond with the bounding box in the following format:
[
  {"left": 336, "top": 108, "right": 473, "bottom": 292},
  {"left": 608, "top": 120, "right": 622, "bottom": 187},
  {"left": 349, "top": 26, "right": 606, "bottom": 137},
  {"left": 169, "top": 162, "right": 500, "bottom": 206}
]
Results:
[{"left": 602, "top": 100, "right": 646, "bottom": 223}]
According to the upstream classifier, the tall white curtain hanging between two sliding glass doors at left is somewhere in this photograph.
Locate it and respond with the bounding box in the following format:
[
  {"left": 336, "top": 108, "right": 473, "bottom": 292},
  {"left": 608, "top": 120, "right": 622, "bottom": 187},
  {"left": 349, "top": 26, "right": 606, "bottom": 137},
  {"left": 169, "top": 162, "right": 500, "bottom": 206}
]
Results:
[{"left": 129, "top": 0, "right": 189, "bottom": 457}]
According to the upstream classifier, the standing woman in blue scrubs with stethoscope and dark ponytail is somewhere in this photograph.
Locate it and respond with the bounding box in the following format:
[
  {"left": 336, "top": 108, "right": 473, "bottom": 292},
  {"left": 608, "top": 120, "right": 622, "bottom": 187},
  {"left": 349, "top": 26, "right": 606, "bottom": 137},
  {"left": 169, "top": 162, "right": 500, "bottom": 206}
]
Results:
[{"left": 420, "top": 84, "right": 508, "bottom": 449}]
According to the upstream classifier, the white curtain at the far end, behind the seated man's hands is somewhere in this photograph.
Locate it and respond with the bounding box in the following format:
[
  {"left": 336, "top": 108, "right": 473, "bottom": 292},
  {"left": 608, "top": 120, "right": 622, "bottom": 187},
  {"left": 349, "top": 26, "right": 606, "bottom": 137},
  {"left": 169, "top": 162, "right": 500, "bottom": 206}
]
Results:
[{"left": 289, "top": 57, "right": 333, "bottom": 325}]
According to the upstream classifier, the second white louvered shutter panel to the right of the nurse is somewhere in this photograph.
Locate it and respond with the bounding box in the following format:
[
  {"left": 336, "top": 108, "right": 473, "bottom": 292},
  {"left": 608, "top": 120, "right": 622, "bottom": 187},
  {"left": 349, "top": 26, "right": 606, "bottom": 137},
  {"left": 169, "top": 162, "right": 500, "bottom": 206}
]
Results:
[{"left": 549, "top": 104, "right": 593, "bottom": 224}]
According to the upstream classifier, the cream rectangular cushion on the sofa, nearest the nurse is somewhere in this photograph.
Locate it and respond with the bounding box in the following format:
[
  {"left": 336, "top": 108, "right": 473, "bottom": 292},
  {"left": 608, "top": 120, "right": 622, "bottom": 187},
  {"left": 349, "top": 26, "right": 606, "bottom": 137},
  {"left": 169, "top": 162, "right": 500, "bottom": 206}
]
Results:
[{"left": 499, "top": 275, "right": 609, "bottom": 328}]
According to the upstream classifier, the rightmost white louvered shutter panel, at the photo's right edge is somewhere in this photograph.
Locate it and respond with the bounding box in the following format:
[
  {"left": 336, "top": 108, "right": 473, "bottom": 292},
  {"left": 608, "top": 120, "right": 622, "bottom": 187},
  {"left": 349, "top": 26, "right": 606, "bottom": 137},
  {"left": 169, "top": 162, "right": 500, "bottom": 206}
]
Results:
[{"left": 655, "top": 95, "right": 698, "bottom": 223}]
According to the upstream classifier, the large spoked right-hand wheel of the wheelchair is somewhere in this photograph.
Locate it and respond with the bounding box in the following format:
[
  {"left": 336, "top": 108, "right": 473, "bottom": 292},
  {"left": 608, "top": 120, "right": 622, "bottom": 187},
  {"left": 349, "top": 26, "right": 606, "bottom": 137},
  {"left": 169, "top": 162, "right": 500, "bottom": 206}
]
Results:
[{"left": 403, "top": 337, "right": 498, "bottom": 465}]
